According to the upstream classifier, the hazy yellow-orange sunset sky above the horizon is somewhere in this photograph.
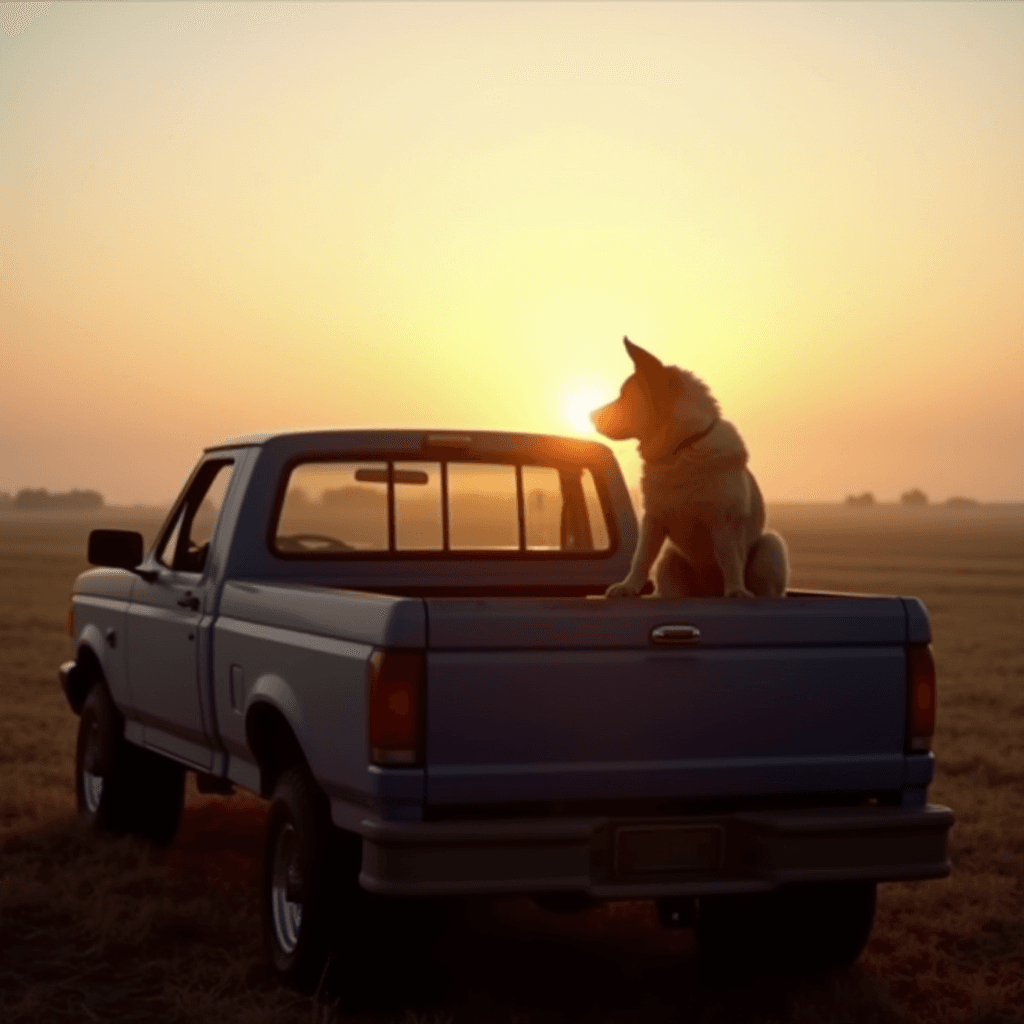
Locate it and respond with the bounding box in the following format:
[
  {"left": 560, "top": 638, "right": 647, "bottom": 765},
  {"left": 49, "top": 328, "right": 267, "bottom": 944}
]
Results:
[{"left": 0, "top": 2, "right": 1024, "bottom": 503}]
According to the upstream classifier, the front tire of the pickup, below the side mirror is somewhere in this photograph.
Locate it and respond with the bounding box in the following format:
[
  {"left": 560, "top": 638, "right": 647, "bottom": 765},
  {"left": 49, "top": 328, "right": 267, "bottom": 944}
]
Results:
[{"left": 75, "top": 682, "right": 185, "bottom": 846}]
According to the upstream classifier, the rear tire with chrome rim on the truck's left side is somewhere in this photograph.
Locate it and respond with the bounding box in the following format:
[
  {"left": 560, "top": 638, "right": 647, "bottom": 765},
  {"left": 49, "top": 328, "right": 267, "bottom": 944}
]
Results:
[{"left": 261, "top": 768, "right": 366, "bottom": 992}]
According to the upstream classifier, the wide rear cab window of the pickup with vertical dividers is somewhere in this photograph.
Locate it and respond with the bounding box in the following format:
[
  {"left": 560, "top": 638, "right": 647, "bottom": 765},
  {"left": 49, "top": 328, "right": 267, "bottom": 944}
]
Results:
[{"left": 271, "top": 460, "right": 610, "bottom": 558}]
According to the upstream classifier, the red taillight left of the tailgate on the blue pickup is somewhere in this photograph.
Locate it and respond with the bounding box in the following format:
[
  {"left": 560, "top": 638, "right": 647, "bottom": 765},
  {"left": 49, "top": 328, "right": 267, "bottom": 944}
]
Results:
[{"left": 368, "top": 650, "right": 423, "bottom": 765}]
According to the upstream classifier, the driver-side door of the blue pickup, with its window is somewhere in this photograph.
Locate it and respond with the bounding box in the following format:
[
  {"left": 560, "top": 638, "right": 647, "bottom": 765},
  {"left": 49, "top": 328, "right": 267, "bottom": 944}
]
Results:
[{"left": 127, "top": 459, "right": 233, "bottom": 769}]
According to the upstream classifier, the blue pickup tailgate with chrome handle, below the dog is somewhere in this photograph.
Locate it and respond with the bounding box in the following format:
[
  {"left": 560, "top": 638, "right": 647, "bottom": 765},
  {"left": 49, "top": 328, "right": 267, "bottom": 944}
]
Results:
[{"left": 426, "top": 597, "right": 907, "bottom": 806}]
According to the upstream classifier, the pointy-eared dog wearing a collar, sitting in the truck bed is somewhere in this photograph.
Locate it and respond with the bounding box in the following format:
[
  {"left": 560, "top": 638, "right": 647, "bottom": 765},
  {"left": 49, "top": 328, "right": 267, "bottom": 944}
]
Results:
[{"left": 590, "top": 338, "right": 790, "bottom": 597}]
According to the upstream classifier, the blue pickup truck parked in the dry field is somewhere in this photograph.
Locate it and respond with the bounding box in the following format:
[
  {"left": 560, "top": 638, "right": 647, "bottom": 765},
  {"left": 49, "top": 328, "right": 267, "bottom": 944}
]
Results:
[{"left": 59, "top": 430, "right": 953, "bottom": 988}]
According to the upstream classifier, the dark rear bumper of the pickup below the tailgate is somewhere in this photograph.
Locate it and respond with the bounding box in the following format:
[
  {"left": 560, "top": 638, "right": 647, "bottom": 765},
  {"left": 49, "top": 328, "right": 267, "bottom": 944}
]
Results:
[{"left": 358, "top": 805, "right": 953, "bottom": 899}]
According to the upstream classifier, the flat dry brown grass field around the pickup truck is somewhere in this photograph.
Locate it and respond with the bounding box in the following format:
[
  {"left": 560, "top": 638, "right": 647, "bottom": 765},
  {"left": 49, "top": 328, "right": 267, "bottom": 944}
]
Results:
[{"left": 0, "top": 506, "right": 1024, "bottom": 1024}]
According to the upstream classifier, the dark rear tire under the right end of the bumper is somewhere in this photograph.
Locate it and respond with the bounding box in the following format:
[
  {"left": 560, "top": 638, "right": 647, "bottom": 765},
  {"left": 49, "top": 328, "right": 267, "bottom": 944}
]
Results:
[{"left": 696, "top": 882, "right": 877, "bottom": 983}]
